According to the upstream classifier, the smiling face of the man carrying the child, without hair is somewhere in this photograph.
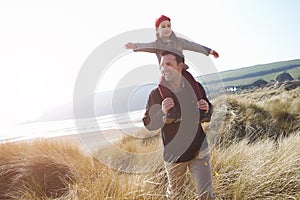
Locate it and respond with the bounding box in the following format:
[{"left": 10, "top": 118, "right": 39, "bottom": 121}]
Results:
[{"left": 160, "top": 54, "right": 183, "bottom": 82}]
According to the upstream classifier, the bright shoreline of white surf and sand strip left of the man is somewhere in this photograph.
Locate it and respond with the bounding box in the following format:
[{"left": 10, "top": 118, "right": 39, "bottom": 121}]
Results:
[{"left": 0, "top": 110, "right": 144, "bottom": 145}]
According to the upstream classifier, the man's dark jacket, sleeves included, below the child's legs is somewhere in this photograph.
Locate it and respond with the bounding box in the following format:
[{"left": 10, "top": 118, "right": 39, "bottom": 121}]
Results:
[{"left": 142, "top": 80, "right": 212, "bottom": 163}]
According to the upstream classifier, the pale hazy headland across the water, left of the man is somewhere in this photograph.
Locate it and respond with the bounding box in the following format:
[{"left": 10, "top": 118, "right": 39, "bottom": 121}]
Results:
[{"left": 38, "top": 84, "right": 156, "bottom": 121}]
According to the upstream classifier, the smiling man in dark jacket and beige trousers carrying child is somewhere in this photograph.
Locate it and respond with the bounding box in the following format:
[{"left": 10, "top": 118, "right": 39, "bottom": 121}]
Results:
[{"left": 143, "top": 50, "right": 214, "bottom": 199}]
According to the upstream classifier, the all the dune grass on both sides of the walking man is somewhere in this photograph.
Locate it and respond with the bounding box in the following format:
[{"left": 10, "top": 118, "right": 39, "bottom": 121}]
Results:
[{"left": 0, "top": 85, "right": 300, "bottom": 200}]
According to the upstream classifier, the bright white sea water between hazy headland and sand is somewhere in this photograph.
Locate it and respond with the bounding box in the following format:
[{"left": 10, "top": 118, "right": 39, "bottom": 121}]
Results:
[{"left": 0, "top": 110, "right": 145, "bottom": 143}]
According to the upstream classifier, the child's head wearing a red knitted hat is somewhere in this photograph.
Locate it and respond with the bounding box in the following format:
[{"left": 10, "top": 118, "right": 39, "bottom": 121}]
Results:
[{"left": 155, "top": 15, "right": 172, "bottom": 38}]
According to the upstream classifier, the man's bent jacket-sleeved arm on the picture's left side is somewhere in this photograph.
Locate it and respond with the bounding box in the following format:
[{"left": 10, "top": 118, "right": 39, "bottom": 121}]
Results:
[{"left": 142, "top": 89, "right": 164, "bottom": 131}]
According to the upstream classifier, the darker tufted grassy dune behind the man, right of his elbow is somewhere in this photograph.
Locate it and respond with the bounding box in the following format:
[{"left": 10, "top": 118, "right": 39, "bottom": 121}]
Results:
[{"left": 208, "top": 87, "right": 300, "bottom": 145}]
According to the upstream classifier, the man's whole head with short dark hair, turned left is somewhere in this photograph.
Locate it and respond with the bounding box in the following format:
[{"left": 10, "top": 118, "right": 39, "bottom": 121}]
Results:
[{"left": 160, "top": 51, "right": 184, "bottom": 82}]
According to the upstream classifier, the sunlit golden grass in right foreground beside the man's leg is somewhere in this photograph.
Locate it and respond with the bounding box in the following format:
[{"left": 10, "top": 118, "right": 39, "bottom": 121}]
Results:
[{"left": 211, "top": 134, "right": 300, "bottom": 199}]
